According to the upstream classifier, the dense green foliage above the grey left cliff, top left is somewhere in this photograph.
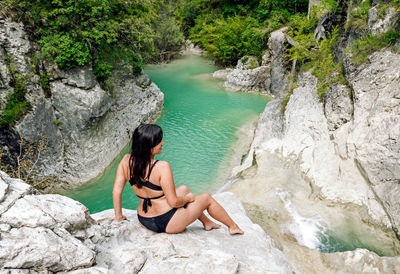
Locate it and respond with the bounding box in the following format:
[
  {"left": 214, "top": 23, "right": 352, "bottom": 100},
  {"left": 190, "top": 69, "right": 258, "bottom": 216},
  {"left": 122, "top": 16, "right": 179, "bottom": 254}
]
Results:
[{"left": 0, "top": 0, "right": 183, "bottom": 85}]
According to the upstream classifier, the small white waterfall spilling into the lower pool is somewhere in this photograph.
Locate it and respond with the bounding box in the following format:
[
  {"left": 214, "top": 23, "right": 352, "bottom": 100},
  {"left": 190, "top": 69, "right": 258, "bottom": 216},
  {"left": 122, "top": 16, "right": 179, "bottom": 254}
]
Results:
[{"left": 276, "top": 189, "right": 327, "bottom": 249}]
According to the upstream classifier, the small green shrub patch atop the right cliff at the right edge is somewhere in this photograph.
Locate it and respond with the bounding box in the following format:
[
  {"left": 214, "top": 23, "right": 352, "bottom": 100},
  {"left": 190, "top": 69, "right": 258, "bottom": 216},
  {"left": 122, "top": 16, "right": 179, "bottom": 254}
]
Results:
[{"left": 350, "top": 30, "right": 400, "bottom": 65}]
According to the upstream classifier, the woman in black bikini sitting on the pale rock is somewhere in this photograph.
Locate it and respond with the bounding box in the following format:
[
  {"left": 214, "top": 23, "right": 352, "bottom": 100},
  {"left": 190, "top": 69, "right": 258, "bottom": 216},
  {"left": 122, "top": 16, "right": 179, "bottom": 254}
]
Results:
[{"left": 113, "top": 124, "right": 243, "bottom": 234}]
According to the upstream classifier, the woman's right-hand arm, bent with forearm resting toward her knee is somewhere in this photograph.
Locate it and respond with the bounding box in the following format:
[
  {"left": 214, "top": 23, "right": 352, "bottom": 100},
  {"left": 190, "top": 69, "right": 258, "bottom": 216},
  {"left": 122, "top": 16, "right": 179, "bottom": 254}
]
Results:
[{"left": 160, "top": 161, "right": 194, "bottom": 207}]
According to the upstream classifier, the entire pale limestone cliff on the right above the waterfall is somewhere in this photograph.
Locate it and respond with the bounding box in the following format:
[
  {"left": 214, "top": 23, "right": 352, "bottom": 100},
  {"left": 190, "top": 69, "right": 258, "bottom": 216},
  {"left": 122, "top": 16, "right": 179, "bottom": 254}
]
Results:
[{"left": 228, "top": 0, "right": 400, "bottom": 234}]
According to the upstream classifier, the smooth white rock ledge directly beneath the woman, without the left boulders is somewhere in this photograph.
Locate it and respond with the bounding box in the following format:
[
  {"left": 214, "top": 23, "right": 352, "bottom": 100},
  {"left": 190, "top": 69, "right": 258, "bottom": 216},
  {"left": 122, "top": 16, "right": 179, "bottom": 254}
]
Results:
[{"left": 92, "top": 193, "right": 291, "bottom": 273}]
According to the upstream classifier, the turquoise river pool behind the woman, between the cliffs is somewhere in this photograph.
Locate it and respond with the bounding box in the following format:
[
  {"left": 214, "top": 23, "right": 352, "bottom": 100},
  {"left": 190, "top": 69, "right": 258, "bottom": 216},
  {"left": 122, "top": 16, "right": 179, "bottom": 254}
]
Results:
[{"left": 63, "top": 55, "right": 268, "bottom": 213}]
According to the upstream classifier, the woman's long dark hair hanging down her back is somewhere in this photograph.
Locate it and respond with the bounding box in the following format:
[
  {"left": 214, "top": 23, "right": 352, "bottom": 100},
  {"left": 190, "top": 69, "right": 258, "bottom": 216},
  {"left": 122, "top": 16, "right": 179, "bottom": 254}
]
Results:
[{"left": 129, "top": 124, "right": 163, "bottom": 188}]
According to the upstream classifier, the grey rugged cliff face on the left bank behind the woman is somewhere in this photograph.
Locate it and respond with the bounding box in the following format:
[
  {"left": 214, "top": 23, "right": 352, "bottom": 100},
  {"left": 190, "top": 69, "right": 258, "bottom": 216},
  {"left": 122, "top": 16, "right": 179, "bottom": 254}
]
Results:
[{"left": 0, "top": 20, "right": 163, "bottom": 188}]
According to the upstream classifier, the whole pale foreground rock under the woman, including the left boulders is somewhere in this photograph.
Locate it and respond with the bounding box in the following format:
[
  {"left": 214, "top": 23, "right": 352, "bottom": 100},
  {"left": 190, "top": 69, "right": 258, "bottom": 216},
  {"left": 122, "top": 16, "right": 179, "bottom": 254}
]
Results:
[{"left": 0, "top": 172, "right": 292, "bottom": 274}]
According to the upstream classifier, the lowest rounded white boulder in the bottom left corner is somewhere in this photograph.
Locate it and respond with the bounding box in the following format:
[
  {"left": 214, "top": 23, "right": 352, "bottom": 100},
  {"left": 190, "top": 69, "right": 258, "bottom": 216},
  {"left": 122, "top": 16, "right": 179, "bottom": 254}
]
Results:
[{"left": 0, "top": 227, "right": 95, "bottom": 271}]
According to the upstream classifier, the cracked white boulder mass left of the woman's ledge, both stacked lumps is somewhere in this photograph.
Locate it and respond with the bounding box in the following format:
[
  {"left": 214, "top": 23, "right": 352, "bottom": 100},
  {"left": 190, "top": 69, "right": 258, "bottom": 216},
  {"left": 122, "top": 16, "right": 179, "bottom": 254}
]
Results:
[{"left": 0, "top": 172, "right": 95, "bottom": 273}]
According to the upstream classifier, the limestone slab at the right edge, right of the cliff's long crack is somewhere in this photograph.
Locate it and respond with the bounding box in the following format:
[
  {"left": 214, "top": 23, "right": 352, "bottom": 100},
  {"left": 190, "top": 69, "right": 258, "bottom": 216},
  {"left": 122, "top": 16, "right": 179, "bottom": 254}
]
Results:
[{"left": 347, "top": 51, "right": 400, "bottom": 238}]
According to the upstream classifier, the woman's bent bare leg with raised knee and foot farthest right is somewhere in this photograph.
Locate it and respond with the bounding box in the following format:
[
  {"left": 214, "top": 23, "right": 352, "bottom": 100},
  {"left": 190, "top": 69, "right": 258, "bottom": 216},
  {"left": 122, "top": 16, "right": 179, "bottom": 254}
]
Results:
[{"left": 166, "top": 193, "right": 243, "bottom": 234}]
